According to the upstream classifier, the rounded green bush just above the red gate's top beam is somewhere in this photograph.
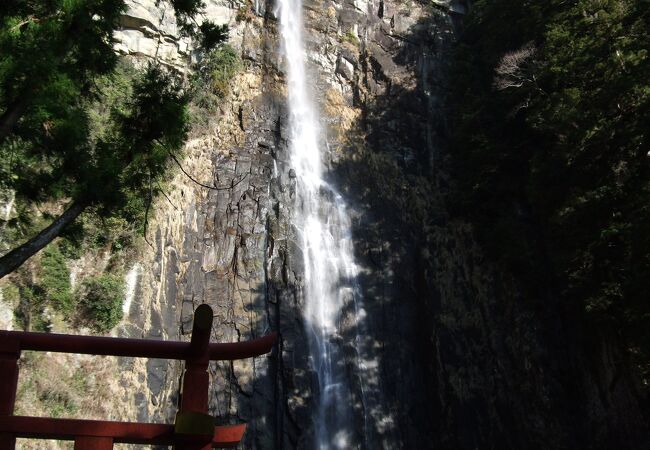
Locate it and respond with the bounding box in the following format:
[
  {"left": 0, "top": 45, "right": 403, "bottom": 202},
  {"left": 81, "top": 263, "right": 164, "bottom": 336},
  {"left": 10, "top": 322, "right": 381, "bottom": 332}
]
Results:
[{"left": 78, "top": 274, "right": 125, "bottom": 333}]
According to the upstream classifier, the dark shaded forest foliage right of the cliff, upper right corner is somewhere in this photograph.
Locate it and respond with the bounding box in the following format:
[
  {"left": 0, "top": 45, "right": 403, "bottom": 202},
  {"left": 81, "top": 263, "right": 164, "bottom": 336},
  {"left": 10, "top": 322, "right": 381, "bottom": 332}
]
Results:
[{"left": 452, "top": 0, "right": 650, "bottom": 381}]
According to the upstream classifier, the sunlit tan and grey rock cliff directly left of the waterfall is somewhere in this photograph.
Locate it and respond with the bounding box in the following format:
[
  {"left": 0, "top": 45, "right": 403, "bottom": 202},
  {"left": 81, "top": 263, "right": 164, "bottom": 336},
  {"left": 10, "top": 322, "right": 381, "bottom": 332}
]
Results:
[{"left": 112, "top": 2, "right": 299, "bottom": 442}]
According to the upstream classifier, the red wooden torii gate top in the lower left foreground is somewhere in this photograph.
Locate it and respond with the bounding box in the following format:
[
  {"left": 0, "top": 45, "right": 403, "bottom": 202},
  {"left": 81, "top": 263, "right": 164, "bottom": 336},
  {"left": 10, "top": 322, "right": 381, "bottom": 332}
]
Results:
[{"left": 0, "top": 304, "right": 276, "bottom": 450}]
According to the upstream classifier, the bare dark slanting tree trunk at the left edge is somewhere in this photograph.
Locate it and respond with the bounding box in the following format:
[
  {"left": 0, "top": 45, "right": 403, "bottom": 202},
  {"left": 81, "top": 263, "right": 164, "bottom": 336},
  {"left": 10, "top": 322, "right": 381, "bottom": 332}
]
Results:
[{"left": 0, "top": 202, "right": 88, "bottom": 278}]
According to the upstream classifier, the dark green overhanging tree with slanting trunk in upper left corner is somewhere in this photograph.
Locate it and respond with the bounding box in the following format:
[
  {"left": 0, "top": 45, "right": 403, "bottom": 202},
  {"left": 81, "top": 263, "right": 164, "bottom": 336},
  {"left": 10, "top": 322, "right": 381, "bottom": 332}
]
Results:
[{"left": 0, "top": 0, "right": 227, "bottom": 278}]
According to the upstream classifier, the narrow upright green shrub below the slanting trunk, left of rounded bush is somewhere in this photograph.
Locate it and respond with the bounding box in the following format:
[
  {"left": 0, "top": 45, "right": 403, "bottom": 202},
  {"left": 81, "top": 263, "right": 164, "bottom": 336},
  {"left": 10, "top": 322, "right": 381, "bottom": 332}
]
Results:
[{"left": 39, "top": 245, "right": 75, "bottom": 318}]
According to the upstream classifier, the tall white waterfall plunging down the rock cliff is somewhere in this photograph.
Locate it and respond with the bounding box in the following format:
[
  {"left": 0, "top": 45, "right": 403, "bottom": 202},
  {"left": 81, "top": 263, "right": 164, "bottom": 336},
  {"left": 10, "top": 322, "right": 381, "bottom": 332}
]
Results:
[{"left": 278, "top": 0, "right": 363, "bottom": 450}]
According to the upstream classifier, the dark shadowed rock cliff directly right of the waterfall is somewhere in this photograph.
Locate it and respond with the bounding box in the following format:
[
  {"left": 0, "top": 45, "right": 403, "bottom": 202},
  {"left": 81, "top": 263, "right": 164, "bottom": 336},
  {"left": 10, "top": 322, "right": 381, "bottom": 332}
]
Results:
[{"left": 322, "top": 1, "right": 648, "bottom": 449}]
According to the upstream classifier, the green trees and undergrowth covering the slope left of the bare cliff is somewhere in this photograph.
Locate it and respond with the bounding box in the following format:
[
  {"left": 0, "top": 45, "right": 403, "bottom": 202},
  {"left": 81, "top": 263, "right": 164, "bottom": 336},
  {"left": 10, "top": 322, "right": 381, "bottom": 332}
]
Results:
[{"left": 0, "top": 0, "right": 241, "bottom": 338}]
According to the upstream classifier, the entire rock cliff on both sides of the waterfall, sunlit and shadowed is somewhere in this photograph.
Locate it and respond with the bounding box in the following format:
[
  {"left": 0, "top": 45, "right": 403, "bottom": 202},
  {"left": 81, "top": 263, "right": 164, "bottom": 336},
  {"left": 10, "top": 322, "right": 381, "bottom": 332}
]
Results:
[{"left": 118, "top": 0, "right": 644, "bottom": 450}]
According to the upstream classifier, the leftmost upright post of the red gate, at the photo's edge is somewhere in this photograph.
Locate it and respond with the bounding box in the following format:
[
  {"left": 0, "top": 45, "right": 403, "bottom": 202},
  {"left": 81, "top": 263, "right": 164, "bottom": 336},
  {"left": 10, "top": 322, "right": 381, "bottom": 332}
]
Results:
[{"left": 0, "top": 339, "right": 20, "bottom": 450}]
